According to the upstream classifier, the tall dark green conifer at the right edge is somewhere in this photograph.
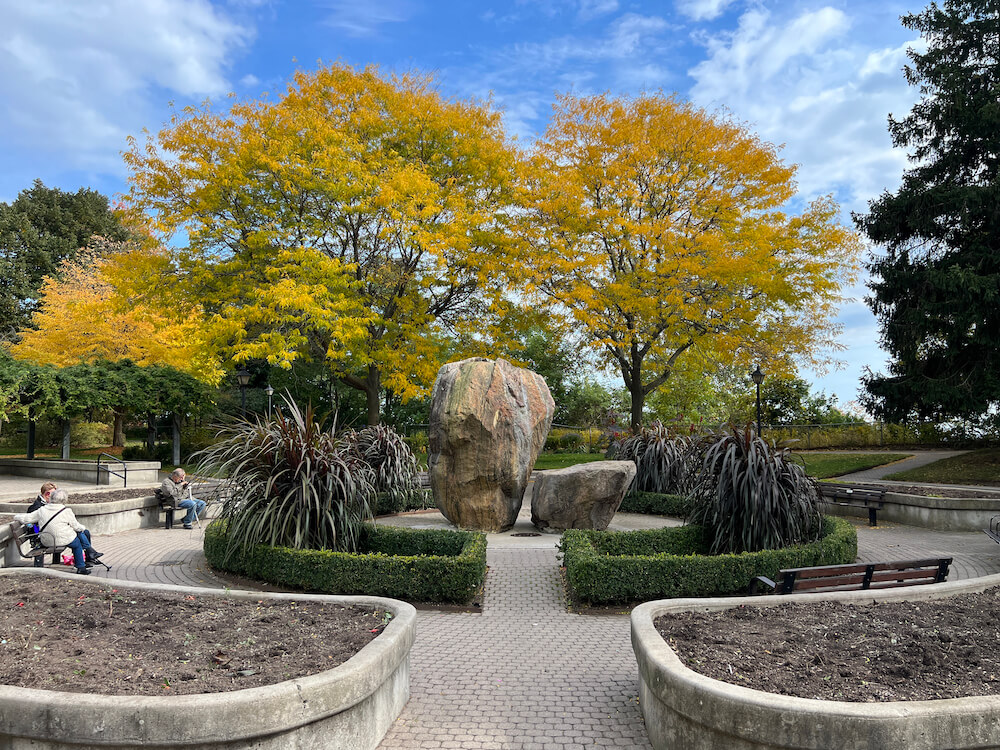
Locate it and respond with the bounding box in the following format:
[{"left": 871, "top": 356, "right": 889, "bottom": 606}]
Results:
[{"left": 854, "top": 0, "right": 1000, "bottom": 421}]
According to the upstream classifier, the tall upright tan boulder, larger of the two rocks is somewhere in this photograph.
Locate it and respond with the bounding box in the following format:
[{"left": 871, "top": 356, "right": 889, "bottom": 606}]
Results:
[{"left": 427, "top": 357, "right": 555, "bottom": 531}]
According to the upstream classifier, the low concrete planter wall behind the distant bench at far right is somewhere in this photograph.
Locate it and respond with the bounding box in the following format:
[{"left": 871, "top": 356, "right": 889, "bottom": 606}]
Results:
[{"left": 824, "top": 492, "right": 1000, "bottom": 531}]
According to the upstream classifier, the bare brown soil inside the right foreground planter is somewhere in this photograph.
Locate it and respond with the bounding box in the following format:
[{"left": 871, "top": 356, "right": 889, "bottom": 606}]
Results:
[{"left": 655, "top": 589, "right": 1000, "bottom": 702}]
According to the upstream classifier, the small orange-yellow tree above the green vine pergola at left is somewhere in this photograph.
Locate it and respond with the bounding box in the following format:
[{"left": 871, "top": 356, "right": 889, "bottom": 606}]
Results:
[{"left": 10, "top": 239, "right": 221, "bottom": 383}]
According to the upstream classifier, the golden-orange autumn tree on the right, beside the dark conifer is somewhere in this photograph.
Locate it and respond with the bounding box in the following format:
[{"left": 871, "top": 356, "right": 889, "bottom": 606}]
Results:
[{"left": 522, "top": 94, "right": 860, "bottom": 430}]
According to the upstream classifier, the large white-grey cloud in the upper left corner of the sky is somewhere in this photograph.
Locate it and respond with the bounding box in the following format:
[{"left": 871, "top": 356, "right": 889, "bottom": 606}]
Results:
[{"left": 0, "top": 0, "right": 252, "bottom": 171}]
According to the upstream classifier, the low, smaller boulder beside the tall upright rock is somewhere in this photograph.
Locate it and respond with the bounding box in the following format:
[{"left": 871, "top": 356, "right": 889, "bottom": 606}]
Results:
[{"left": 531, "top": 461, "right": 635, "bottom": 531}]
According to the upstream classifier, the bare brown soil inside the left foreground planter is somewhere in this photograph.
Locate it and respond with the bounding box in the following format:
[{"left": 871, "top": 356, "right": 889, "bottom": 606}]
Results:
[{"left": 0, "top": 576, "right": 391, "bottom": 695}]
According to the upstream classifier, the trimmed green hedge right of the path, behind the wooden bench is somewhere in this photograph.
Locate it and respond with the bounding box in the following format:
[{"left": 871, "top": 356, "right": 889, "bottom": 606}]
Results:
[{"left": 560, "top": 517, "right": 858, "bottom": 604}]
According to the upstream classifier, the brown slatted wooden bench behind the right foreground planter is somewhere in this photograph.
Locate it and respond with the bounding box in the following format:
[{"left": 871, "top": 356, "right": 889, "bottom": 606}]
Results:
[{"left": 747, "top": 557, "right": 952, "bottom": 595}]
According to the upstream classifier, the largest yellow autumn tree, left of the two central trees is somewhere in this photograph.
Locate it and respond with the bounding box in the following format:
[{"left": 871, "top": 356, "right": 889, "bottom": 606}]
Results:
[{"left": 125, "top": 65, "right": 519, "bottom": 424}]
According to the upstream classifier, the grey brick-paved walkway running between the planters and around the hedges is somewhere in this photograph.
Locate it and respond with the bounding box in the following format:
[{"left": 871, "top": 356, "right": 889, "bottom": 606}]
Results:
[{"left": 23, "top": 508, "right": 1000, "bottom": 750}]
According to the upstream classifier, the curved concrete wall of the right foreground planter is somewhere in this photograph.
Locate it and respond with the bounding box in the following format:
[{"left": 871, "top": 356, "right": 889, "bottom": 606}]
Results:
[{"left": 632, "top": 575, "right": 1000, "bottom": 750}]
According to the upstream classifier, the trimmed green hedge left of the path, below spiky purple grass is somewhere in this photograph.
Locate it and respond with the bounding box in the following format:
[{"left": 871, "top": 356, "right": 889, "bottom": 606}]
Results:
[{"left": 205, "top": 522, "right": 486, "bottom": 604}]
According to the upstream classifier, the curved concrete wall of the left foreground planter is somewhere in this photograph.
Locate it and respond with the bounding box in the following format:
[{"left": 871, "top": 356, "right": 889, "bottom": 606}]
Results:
[{"left": 0, "top": 570, "right": 416, "bottom": 750}]
